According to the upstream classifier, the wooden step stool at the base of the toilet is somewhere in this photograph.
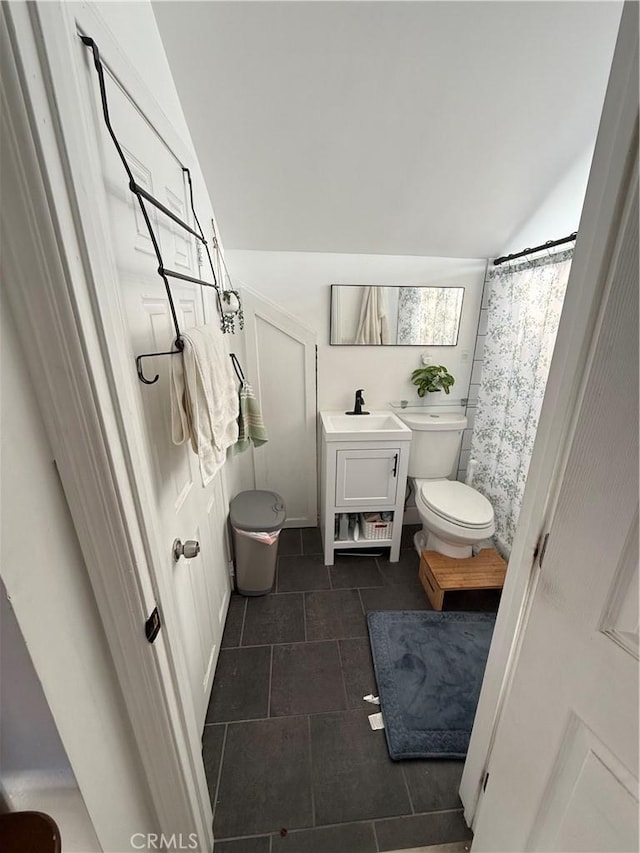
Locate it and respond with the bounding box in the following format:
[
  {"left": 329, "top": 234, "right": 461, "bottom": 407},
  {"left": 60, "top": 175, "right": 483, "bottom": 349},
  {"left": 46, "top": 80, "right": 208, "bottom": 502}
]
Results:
[{"left": 419, "top": 548, "right": 507, "bottom": 610}]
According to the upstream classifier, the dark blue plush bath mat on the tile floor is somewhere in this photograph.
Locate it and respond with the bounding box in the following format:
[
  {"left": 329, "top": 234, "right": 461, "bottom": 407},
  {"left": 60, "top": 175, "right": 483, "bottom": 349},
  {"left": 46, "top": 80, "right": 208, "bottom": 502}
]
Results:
[{"left": 367, "top": 610, "right": 496, "bottom": 760}]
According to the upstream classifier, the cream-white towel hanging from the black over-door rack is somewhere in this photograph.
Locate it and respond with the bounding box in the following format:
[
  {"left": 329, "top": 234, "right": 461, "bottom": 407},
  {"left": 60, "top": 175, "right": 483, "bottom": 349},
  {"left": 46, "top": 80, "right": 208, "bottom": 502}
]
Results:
[{"left": 171, "top": 326, "right": 238, "bottom": 486}]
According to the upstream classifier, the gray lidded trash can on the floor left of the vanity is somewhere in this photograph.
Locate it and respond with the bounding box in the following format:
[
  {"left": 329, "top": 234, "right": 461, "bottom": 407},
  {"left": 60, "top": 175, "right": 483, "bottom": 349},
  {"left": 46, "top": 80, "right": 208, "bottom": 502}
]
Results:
[{"left": 229, "top": 489, "right": 286, "bottom": 595}]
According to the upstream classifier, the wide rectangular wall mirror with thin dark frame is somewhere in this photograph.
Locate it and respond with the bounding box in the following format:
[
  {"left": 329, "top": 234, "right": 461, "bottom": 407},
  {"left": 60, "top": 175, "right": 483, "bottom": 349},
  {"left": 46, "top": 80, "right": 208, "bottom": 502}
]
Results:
[{"left": 330, "top": 284, "right": 464, "bottom": 347}]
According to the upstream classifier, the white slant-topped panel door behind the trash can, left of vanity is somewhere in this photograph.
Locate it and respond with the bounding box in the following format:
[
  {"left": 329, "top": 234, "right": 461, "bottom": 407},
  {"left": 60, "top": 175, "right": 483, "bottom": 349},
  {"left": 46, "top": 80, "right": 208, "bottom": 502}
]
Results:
[{"left": 242, "top": 288, "right": 318, "bottom": 527}]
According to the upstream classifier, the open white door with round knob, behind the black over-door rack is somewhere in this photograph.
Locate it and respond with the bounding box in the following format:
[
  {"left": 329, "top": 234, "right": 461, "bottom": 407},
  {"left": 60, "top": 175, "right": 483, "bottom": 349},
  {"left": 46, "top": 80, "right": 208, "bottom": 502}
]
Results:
[{"left": 88, "top": 58, "right": 230, "bottom": 725}]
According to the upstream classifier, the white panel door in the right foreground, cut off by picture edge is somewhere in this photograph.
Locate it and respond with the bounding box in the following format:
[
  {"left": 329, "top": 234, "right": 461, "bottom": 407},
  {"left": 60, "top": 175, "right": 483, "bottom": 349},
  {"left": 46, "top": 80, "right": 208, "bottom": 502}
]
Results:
[{"left": 473, "top": 158, "right": 638, "bottom": 853}]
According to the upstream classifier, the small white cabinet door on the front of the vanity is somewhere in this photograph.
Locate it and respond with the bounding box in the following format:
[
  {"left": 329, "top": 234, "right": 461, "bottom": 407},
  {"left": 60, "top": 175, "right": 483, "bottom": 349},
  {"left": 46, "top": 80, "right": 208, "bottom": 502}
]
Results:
[{"left": 336, "top": 447, "right": 400, "bottom": 507}]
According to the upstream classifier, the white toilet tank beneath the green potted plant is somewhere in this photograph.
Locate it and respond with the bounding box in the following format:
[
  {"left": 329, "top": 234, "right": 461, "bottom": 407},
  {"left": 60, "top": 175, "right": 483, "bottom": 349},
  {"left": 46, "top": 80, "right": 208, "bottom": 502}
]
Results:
[{"left": 398, "top": 412, "right": 467, "bottom": 480}]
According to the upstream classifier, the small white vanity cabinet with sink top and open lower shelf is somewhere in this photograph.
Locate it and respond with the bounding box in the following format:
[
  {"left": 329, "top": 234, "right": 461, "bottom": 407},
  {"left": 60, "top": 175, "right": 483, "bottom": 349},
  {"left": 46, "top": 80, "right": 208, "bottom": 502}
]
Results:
[{"left": 320, "top": 412, "right": 411, "bottom": 566}]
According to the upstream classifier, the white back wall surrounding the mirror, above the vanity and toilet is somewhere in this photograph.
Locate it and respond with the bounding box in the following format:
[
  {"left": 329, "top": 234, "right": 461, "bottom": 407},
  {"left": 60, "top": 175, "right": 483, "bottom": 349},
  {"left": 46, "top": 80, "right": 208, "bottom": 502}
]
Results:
[{"left": 226, "top": 251, "right": 486, "bottom": 410}]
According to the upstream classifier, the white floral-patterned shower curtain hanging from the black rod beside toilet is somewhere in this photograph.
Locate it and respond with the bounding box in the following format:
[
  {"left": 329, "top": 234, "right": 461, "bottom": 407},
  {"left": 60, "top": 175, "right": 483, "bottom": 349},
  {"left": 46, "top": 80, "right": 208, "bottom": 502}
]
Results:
[{"left": 471, "top": 249, "right": 573, "bottom": 553}]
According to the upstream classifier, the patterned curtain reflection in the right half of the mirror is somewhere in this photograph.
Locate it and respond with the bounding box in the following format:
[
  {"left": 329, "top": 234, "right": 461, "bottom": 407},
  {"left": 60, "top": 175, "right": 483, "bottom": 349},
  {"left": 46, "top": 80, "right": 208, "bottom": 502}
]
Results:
[{"left": 398, "top": 287, "right": 463, "bottom": 346}]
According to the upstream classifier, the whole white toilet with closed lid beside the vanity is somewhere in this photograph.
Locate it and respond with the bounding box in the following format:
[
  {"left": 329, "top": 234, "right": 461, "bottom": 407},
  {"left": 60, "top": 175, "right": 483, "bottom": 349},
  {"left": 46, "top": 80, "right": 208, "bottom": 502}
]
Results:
[{"left": 398, "top": 412, "right": 494, "bottom": 559}]
